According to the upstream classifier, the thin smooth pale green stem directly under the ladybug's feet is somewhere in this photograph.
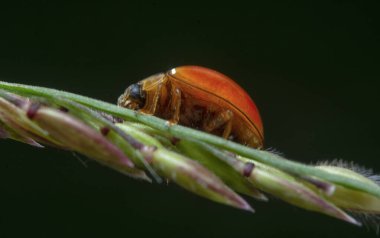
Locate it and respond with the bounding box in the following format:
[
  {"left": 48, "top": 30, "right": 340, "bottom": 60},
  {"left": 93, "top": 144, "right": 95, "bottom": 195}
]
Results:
[{"left": 0, "top": 81, "right": 380, "bottom": 198}]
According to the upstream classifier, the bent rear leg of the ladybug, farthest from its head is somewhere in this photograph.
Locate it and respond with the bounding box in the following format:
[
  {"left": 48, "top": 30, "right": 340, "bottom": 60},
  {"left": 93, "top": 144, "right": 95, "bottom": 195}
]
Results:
[{"left": 203, "top": 110, "right": 233, "bottom": 138}]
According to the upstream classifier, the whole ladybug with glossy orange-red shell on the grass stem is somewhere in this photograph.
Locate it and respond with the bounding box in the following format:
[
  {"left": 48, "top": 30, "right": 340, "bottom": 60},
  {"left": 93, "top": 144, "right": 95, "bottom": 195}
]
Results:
[{"left": 118, "top": 66, "right": 264, "bottom": 148}]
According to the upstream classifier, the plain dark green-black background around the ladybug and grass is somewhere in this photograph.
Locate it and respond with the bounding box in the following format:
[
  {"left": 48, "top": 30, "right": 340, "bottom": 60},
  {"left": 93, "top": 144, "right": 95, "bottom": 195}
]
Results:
[{"left": 0, "top": 1, "right": 380, "bottom": 237}]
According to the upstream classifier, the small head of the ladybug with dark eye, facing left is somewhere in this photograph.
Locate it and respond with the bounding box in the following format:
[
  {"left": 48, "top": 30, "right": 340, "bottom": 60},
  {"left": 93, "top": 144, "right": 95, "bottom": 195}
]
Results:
[{"left": 117, "top": 83, "right": 146, "bottom": 110}]
